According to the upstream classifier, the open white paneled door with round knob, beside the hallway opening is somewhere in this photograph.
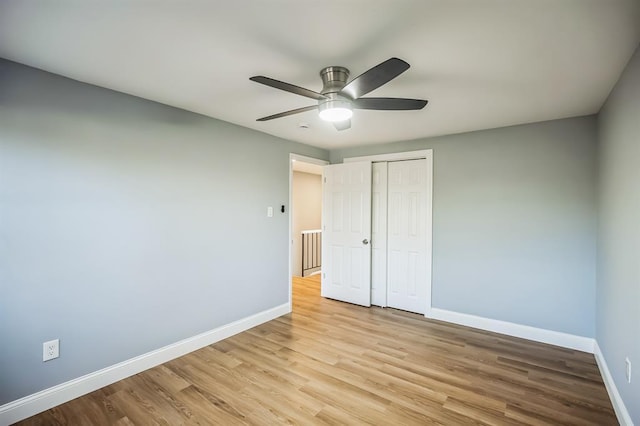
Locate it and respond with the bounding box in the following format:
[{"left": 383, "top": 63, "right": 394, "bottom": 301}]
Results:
[{"left": 321, "top": 161, "right": 371, "bottom": 306}]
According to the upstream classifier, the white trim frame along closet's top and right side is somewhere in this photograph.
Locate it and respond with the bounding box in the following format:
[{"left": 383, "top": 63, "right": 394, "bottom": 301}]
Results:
[{"left": 343, "top": 149, "right": 433, "bottom": 318}]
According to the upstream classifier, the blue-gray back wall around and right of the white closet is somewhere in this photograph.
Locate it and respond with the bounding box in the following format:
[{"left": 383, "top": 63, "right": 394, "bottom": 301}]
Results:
[{"left": 331, "top": 117, "right": 596, "bottom": 337}]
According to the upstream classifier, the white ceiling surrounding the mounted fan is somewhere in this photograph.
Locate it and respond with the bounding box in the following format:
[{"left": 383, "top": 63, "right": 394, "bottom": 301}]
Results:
[{"left": 0, "top": 0, "right": 640, "bottom": 148}]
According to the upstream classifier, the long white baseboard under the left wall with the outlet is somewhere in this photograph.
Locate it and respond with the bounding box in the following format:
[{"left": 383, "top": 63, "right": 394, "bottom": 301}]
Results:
[{"left": 0, "top": 303, "right": 291, "bottom": 425}]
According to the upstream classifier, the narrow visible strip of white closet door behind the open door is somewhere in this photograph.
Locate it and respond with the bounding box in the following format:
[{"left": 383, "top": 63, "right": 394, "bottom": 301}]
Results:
[{"left": 371, "top": 161, "right": 387, "bottom": 307}]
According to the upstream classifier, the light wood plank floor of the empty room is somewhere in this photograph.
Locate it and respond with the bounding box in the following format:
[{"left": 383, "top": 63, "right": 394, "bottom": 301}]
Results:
[{"left": 22, "top": 278, "right": 618, "bottom": 425}]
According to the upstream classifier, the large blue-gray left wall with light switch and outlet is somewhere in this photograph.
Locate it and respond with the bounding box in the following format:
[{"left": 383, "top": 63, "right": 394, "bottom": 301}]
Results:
[{"left": 0, "top": 61, "right": 328, "bottom": 404}]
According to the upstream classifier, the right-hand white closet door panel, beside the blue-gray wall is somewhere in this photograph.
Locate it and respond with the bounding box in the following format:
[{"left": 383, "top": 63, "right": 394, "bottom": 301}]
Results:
[{"left": 387, "top": 160, "right": 430, "bottom": 314}]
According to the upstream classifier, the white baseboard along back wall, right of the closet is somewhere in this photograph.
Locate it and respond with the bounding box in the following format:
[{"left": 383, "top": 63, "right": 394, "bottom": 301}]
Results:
[{"left": 425, "top": 308, "right": 594, "bottom": 354}]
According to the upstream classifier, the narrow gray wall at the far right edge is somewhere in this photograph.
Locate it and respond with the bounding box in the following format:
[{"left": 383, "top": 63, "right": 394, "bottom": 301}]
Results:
[{"left": 596, "top": 43, "right": 640, "bottom": 424}]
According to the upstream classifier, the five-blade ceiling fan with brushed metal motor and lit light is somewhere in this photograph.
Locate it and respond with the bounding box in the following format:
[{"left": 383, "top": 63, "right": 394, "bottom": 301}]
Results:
[{"left": 250, "top": 58, "right": 427, "bottom": 130}]
